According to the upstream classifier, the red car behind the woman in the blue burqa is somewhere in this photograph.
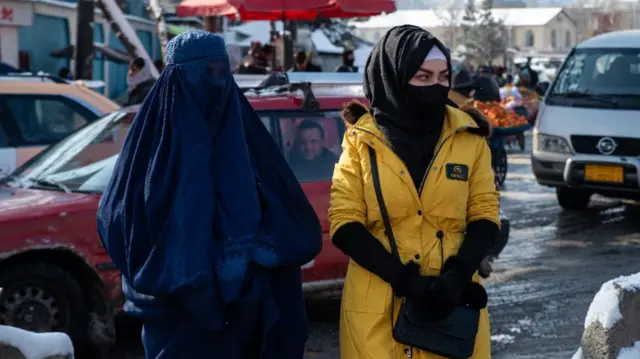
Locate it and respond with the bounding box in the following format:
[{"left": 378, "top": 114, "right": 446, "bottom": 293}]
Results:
[{"left": 0, "top": 82, "right": 364, "bottom": 347}]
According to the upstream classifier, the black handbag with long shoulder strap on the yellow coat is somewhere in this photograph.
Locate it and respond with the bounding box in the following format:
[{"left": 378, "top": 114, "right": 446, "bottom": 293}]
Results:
[{"left": 369, "top": 147, "right": 480, "bottom": 359}]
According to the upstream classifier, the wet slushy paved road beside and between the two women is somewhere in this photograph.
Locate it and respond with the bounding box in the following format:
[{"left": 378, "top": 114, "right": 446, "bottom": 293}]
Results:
[{"left": 105, "top": 137, "right": 640, "bottom": 359}]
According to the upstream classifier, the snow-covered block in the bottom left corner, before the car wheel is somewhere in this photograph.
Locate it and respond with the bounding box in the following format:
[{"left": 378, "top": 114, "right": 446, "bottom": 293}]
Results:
[{"left": 0, "top": 326, "right": 73, "bottom": 359}]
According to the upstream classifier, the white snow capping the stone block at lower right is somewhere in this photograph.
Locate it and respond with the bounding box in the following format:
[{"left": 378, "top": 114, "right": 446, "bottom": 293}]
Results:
[{"left": 584, "top": 273, "right": 640, "bottom": 329}]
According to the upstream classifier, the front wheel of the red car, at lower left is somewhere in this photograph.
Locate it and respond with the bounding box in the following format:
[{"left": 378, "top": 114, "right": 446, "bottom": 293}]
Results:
[{"left": 0, "top": 263, "right": 88, "bottom": 341}]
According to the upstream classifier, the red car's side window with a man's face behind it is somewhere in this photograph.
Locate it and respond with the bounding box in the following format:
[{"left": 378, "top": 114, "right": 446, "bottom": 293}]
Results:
[{"left": 276, "top": 111, "right": 344, "bottom": 182}]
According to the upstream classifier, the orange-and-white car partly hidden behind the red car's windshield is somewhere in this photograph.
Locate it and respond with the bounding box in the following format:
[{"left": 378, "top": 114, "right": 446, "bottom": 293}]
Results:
[{"left": 0, "top": 74, "right": 120, "bottom": 178}]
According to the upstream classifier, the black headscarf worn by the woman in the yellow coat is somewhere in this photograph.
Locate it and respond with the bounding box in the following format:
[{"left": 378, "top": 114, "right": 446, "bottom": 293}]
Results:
[{"left": 364, "top": 25, "right": 455, "bottom": 188}]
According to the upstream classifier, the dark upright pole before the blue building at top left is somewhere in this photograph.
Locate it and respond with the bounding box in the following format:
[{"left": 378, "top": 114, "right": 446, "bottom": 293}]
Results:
[{"left": 74, "top": 0, "right": 95, "bottom": 80}]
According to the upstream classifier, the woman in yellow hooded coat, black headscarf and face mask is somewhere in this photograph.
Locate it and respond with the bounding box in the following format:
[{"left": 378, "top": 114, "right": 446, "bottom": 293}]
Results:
[{"left": 329, "top": 25, "right": 500, "bottom": 359}]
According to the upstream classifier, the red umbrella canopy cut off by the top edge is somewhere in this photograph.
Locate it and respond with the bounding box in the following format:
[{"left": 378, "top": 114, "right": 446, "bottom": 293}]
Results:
[{"left": 176, "top": 0, "right": 396, "bottom": 21}]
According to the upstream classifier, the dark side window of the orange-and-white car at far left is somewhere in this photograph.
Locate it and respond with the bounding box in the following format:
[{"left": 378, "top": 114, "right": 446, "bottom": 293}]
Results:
[{"left": 0, "top": 95, "right": 98, "bottom": 147}]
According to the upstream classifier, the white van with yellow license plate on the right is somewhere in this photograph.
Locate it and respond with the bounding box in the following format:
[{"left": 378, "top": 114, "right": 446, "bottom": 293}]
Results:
[{"left": 531, "top": 30, "right": 640, "bottom": 210}]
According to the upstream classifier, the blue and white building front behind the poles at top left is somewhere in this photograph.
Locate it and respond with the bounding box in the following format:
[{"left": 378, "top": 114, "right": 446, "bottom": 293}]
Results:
[{"left": 0, "top": 0, "right": 160, "bottom": 98}]
